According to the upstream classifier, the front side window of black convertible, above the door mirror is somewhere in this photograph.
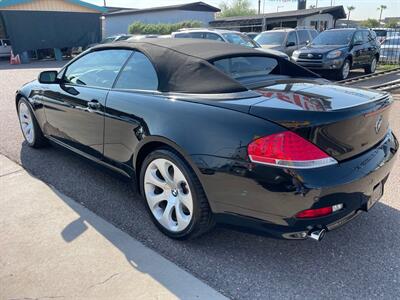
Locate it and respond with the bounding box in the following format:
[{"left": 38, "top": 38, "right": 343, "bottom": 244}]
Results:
[{"left": 63, "top": 50, "right": 132, "bottom": 88}]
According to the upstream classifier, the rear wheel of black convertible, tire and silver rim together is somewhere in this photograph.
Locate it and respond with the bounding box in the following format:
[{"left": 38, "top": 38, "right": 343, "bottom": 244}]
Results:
[{"left": 139, "top": 149, "right": 214, "bottom": 239}]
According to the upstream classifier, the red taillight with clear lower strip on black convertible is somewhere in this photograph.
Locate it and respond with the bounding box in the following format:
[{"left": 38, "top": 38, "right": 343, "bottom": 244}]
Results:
[{"left": 247, "top": 131, "right": 337, "bottom": 169}]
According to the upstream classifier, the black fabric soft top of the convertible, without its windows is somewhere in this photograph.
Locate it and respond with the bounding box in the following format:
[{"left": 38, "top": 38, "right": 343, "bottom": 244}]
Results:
[{"left": 92, "top": 38, "right": 313, "bottom": 94}]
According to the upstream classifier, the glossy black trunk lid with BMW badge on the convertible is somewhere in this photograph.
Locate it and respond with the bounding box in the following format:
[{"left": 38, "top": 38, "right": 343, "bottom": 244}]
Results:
[{"left": 249, "top": 81, "right": 392, "bottom": 161}]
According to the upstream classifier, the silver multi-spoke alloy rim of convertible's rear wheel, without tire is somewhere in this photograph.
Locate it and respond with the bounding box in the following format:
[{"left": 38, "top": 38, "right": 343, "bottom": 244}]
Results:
[{"left": 144, "top": 158, "right": 193, "bottom": 232}]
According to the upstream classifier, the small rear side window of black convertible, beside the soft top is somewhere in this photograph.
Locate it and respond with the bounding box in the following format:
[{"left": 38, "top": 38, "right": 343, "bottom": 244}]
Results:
[{"left": 114, "top": 52, "right": 158, "bottom": 91}]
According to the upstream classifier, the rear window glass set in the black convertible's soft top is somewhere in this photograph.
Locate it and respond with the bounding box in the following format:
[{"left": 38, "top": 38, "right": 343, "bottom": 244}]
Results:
[{"left": 214, "top": 56, "right": 278, "bottom": 83}]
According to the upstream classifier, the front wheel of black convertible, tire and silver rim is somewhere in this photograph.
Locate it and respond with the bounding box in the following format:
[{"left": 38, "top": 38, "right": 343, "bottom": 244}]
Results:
[{"left": 17, "top": 97, "right": 47, "bottom": 148}]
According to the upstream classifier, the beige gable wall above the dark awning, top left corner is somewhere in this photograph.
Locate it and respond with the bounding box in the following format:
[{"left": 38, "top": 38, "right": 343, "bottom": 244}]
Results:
[{"left": 0, "top": 0, "right": 99, "bottom": 13}]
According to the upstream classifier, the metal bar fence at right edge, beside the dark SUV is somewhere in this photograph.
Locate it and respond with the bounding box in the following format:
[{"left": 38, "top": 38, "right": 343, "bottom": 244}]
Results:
[{"left": 373, "top": 28, "right": 400, "bottom": 66}]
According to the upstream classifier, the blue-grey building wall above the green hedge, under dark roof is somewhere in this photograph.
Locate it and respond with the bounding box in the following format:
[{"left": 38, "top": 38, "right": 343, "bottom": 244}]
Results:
[{"left": 104, "top": 10, "right": 214, "bottom": 36}]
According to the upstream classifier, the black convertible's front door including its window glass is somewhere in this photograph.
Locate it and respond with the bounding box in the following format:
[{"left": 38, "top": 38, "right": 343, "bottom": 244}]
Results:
[{"left": 42, "top": 49, "right": 132, "bottom": 159}]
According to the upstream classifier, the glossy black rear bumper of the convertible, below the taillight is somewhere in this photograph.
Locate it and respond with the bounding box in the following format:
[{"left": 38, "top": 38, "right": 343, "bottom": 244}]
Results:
[{"left": 193, "top": 132, "right": 399, "bottom": 239}]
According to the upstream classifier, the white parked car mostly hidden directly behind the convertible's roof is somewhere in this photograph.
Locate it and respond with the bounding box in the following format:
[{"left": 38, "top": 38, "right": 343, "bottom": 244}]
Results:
[{"left": 171, "top": 28, "right": 289, "bottom": 60}]
